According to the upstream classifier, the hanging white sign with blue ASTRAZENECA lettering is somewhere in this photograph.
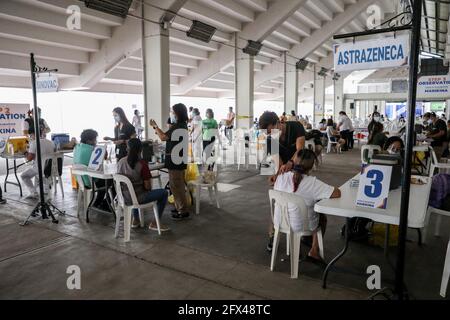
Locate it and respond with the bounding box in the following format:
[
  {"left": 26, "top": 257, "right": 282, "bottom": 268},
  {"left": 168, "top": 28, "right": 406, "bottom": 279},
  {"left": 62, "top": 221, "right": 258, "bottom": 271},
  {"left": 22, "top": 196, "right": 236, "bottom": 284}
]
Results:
[{"left": 334, "top": 35, "right": 409, "bottom": 72}]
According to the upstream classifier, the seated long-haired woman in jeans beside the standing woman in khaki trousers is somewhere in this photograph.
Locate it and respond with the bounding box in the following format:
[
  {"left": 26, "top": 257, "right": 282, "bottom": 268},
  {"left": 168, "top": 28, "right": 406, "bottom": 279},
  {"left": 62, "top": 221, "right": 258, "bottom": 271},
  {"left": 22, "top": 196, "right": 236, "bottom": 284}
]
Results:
[{"left": 117, "top": 138, "right": 170, "bottom": 232}]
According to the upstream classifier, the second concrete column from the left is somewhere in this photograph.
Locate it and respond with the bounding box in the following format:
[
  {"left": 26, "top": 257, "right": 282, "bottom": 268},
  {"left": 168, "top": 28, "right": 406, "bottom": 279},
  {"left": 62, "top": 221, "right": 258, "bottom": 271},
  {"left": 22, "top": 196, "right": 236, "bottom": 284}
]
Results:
[{"left": 234, "top": 37, "right": 254, "bottom": 129}]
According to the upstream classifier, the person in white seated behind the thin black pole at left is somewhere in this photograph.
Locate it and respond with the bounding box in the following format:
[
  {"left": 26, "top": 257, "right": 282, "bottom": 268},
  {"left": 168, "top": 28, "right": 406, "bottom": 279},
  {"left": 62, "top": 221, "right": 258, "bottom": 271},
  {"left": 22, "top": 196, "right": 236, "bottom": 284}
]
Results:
[{"left": 21, "top": 132, "right": 55, "bottom": 199}]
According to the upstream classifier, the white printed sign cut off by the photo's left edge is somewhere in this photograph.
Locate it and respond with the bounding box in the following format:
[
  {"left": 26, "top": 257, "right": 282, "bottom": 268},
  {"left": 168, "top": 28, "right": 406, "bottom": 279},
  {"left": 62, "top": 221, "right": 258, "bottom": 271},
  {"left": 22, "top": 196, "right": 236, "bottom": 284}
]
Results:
[{"left": 0, "top": 103, "right": 30, "bottom": 139}]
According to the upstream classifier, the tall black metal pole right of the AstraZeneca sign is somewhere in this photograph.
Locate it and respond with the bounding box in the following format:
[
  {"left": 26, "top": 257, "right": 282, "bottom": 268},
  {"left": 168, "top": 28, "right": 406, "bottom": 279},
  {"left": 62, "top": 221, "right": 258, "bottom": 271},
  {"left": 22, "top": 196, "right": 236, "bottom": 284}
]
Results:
[{"left": 395, "top": 0, "right": 423, "bottom": 300}]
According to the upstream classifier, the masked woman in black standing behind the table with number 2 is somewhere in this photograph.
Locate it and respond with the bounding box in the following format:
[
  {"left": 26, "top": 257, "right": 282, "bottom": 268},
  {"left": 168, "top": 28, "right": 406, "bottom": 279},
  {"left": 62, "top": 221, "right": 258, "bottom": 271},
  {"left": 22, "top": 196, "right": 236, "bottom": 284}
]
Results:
[{"left": 103, "top": 107, "right": 136, "bottom": 161}]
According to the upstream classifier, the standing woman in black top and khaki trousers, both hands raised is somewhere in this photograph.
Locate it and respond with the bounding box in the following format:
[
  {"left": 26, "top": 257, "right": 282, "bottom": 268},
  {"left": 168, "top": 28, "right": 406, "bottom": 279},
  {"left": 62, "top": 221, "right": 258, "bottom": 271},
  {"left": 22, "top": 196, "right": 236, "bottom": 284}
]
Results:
[{"left": 150, "top": 103, "right": 189, "bottom": 220}]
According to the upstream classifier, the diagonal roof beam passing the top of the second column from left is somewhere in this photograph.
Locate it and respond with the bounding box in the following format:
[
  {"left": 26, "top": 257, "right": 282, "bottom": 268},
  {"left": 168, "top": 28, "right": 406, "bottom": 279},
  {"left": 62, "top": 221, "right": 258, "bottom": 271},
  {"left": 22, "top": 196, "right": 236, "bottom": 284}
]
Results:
[{"left": 174, "top": 0, "right": 306, "bottom": 95}]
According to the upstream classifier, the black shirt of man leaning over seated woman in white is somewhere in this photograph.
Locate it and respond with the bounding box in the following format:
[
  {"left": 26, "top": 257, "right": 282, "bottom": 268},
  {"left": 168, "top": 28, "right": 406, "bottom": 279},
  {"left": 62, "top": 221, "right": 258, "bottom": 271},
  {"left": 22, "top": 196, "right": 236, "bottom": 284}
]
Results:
[{"left": 267, "top": 121, "right": 305, "bottom": 163}]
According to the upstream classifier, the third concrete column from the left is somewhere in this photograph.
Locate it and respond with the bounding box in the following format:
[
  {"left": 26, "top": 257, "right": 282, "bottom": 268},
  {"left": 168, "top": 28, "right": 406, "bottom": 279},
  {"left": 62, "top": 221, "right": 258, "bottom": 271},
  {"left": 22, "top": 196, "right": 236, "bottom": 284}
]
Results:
[{"left": 284, "top": 53, "right": 299, "bottom": 114}]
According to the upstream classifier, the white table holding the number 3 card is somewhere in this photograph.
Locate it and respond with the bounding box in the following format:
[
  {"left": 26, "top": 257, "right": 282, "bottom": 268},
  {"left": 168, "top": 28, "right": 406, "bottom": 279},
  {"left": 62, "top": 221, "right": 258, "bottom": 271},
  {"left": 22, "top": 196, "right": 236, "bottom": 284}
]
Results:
[{"left": 314, "top": 174, "right": 431, "bottom": 288}]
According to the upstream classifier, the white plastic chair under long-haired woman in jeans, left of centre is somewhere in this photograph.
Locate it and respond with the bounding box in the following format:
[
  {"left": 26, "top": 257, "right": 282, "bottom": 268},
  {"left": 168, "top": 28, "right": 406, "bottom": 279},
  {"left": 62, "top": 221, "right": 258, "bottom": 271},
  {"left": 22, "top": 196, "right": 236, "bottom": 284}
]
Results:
[{"left": 113, "top": 174, "right": 161, "bottom": 242}]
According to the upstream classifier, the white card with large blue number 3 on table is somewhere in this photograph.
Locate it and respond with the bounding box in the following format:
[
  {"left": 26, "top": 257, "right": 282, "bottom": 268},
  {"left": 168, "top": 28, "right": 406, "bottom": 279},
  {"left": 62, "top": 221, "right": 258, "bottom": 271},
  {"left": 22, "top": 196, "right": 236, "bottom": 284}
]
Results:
[{"left": 356, "top": 165, "right": 392, "bottom": 209}]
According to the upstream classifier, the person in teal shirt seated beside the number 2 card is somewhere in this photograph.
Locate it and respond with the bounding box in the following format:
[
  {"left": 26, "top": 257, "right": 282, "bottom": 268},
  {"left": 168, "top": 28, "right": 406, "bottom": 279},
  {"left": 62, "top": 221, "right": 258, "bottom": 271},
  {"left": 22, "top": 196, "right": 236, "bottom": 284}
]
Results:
[{"left": 73, "top": 129, "right": 113, "bottom": 211}]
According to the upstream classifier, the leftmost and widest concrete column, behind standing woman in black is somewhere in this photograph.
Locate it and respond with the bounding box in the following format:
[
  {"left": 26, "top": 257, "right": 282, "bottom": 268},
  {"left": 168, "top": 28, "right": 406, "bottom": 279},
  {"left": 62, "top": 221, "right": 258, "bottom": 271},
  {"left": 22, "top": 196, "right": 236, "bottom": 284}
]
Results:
[{"left": 142, "top": 5, "right": 170, "bottom": 139}]
